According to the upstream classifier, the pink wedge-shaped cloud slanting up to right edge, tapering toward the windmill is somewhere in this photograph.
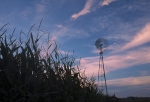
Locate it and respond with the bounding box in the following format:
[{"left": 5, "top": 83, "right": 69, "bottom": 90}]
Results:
[{"left": 121, "top": 23, "right": 150, "bottom": 50}]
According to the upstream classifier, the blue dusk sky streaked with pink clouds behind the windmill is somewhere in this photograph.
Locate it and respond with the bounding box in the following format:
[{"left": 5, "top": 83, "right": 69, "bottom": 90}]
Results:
[{"left": 0, "top": 0, "right": 150, "bottom": 97}]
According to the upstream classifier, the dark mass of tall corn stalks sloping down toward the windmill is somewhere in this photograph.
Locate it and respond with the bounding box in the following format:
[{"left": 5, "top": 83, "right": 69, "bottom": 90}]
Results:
[{"left": 0, "top": 25, "right": 116, "bottom": 102}]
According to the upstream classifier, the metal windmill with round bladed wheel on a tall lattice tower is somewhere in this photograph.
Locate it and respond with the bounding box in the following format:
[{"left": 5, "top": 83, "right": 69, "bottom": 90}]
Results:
[{"left": 95, "top": 38, "right": 108, "bottom": 95}]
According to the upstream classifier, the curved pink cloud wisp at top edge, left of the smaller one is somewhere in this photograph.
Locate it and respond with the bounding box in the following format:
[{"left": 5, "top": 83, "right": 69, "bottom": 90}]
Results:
[{"left": 71, "top": 0, "right": 94, "bottom": 20}]
